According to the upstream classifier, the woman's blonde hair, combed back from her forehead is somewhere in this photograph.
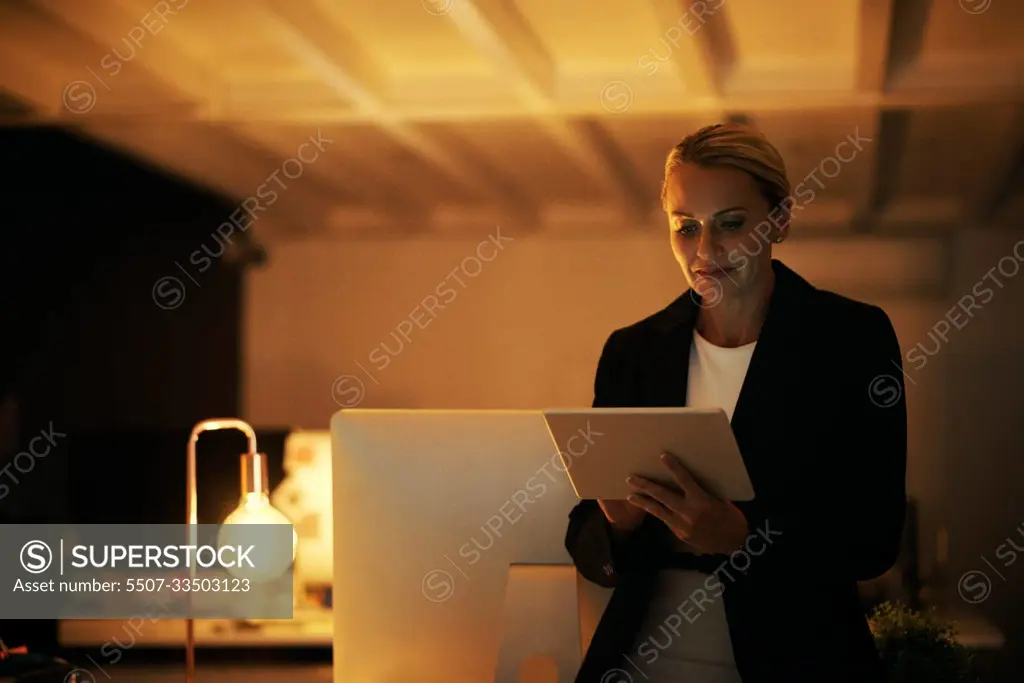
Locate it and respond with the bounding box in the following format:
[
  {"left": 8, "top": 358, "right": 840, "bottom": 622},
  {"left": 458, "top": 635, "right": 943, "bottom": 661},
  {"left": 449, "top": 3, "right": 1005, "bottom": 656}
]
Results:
[{"left": 662, "top": 123, "right": 792, "bottom": 209}]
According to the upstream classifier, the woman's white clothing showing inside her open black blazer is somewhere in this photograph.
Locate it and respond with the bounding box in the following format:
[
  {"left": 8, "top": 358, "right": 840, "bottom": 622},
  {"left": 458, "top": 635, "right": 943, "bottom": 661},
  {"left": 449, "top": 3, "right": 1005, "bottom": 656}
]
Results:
[{"left": 629, "top": 331, "right": 757, "bottom": 683}]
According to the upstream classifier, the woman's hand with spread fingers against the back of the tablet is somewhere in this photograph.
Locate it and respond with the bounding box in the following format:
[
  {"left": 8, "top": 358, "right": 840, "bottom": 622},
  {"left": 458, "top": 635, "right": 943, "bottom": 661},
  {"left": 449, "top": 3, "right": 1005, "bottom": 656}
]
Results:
[{"left": 627, "top": 453, "right": 748, "bottom": 555}]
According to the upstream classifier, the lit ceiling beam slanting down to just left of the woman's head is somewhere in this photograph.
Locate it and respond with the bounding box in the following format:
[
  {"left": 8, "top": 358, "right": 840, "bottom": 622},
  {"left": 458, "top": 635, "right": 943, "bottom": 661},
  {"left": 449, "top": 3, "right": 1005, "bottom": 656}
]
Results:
[{"left": 445, "top": 0, "right": 654, "bottom": 222}]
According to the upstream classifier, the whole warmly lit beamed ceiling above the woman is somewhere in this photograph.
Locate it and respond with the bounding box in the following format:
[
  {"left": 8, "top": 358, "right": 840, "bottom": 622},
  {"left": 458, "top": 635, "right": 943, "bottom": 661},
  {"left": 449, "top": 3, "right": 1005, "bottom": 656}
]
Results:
[{"left": 0, "top": 0, "right": 1024, "bottom": 240}]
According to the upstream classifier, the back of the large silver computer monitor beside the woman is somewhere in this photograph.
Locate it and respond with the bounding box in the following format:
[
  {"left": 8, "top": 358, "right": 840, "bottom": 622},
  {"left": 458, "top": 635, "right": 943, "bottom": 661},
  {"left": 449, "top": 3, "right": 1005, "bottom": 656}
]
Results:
[{"left": 331, "top": 410, "right": 589, "bottom": 683}]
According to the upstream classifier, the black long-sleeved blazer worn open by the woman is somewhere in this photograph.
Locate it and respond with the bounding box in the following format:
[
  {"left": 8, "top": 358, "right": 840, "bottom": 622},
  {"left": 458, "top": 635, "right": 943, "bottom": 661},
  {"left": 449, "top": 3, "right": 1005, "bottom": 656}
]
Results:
[{"left": 565, "top": 260, "right": 906, "bottom": 683}]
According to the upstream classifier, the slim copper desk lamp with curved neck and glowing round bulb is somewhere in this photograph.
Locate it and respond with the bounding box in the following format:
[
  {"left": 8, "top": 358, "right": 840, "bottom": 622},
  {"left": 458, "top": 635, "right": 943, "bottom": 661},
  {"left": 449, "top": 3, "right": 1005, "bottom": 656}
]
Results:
[{"left": 185, "top": 418, "right": 298, "bottom": 683}]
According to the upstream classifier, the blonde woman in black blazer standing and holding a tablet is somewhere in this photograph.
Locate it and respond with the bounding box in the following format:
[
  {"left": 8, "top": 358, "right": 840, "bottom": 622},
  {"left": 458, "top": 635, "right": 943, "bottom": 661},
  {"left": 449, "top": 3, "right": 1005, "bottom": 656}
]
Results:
[{"left": 565, "top": 125, "right": 906, "bottom": 683}]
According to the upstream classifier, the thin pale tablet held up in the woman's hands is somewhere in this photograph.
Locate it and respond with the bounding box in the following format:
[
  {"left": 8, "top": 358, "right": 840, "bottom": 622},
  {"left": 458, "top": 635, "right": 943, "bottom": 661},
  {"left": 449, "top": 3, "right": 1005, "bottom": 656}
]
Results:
[{"left": 544, "top": 408, "right": 754, "bottom": 501}]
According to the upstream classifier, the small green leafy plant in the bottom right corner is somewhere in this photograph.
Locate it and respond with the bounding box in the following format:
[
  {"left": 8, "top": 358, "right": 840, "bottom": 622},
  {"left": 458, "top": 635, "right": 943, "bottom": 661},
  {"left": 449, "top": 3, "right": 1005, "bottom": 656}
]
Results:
[{"left": 868, "top": 602, "right": 978, "bottom": 683}]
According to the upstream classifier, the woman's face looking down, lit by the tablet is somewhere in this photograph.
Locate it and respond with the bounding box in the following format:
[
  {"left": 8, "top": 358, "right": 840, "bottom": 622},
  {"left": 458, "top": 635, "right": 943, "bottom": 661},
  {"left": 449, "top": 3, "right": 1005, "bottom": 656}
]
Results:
[{"left": 665, "top": 164, "right": 787, "bottom": 301}]
